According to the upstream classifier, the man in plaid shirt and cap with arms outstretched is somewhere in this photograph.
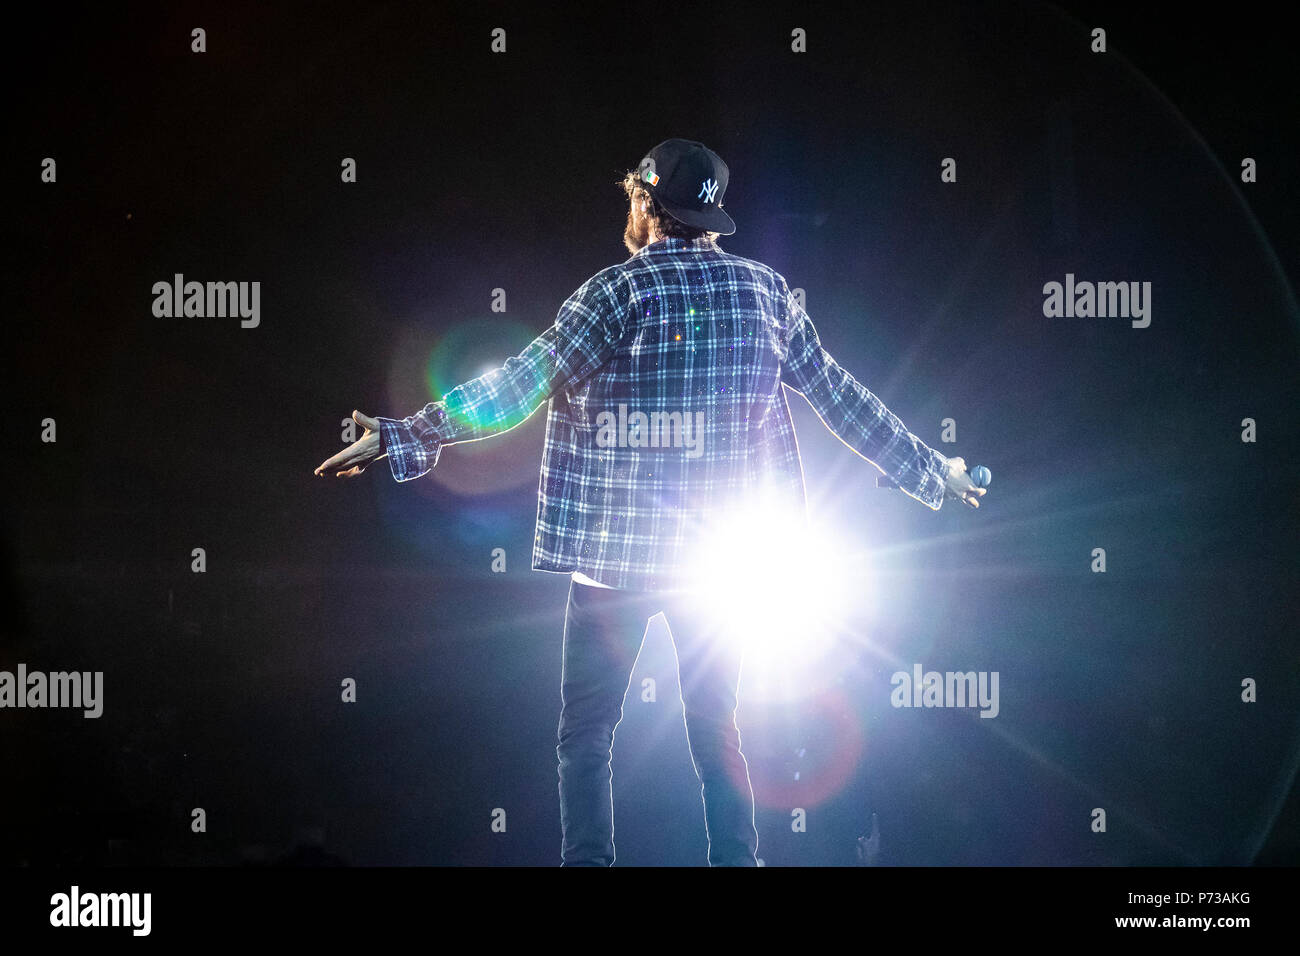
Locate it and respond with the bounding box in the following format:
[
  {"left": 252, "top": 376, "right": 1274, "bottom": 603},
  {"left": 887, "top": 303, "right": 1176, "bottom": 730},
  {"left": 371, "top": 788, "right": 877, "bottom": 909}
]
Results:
[{"left": 316, "top": 139, "right": 984, "bottom": 866}]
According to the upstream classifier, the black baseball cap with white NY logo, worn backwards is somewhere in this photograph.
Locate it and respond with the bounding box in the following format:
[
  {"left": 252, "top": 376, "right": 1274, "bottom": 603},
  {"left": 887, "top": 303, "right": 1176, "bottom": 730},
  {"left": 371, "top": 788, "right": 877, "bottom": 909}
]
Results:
[{"left": 637, "top": 139, "right": 736, "bottom": 235}]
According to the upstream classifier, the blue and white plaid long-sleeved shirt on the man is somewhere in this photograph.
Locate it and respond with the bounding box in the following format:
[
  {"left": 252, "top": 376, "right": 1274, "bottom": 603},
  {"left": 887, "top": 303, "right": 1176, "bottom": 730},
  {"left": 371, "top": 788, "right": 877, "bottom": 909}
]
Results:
[{"left": 380, "top": 237, "right": 948, "bottom": 591}]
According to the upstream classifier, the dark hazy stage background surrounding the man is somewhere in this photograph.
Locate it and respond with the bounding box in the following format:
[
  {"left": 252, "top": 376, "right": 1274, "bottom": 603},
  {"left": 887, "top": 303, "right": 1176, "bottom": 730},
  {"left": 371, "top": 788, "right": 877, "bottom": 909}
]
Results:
[{"left": 0, "top": 3, "right": 1300, "bottom": 866}]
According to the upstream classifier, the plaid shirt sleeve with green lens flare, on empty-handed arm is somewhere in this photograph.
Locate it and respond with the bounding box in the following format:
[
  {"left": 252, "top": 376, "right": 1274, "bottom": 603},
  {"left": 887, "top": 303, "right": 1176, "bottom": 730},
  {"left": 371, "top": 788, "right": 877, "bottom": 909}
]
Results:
[{"left": 378, "top": 267, "right": 629, "bottom": 481}]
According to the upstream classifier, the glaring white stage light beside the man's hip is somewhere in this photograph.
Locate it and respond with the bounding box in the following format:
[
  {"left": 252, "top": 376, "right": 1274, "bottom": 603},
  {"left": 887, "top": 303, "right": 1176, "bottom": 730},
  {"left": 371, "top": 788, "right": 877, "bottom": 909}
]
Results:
[{"left": 696, "top": 502, "right": 870, "bottom": 693}]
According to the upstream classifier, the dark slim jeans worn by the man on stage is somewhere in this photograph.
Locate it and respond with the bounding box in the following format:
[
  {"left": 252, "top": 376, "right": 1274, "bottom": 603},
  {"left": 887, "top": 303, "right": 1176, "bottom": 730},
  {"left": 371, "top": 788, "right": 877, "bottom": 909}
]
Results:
[{"left": 555, "top": 574, "right": 758, "bottom": 866}]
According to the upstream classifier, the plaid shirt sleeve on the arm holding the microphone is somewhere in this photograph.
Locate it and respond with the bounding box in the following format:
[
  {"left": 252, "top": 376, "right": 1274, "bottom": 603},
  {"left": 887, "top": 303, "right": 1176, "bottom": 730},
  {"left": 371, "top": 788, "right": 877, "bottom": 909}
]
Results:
[{"left": 776, "top": 277, "right": 948, "bottom": 511}]
